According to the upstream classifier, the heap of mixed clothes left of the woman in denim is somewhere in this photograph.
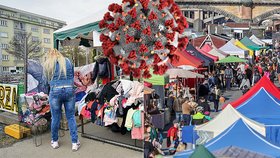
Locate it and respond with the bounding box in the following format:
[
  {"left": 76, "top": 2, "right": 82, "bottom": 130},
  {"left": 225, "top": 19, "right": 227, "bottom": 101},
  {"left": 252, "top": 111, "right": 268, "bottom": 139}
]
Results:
[{"left": 19, "top": 92, "right": 51, "bottom": 132}]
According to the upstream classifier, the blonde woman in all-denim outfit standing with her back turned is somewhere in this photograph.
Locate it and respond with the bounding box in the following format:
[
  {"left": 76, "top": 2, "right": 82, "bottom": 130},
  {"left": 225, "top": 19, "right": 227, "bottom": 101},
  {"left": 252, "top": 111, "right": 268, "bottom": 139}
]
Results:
[{"left": 43, "top": 49, "right": 80, "bottom": 151}]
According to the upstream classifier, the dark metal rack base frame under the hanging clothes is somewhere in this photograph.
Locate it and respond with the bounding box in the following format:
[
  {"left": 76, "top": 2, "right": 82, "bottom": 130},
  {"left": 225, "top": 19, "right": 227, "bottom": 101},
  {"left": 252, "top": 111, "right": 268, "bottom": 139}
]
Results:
[{"left": 80, "top": 116, "right": 144, "bottom": 152}]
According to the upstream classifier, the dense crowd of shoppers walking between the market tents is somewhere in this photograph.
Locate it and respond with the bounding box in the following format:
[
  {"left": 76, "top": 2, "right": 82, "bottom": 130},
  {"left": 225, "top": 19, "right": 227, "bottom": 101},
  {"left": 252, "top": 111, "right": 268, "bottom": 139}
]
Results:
[{"left": 144, "top": 51, "right": 280, "bottom": 157}]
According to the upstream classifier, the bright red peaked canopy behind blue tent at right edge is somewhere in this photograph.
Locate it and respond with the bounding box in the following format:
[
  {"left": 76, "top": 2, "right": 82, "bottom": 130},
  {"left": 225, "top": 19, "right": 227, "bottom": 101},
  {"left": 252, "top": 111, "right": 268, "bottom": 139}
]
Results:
[{"left": 223, "top": 76, "right": 280, "bottom": 108}]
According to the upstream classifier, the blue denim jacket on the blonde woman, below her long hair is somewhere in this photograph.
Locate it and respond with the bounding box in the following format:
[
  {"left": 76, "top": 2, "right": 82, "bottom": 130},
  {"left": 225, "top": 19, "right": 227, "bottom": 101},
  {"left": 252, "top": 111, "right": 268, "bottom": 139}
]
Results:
[{"left": 49, "top": 58, "right": 74, "bottom": 88}]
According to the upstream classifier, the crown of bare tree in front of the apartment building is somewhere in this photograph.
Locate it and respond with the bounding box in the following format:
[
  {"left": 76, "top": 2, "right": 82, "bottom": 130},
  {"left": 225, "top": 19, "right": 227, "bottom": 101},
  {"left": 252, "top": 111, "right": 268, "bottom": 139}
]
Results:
[{"left": 6, "top": 32, "right": 44, "bottom": 59}]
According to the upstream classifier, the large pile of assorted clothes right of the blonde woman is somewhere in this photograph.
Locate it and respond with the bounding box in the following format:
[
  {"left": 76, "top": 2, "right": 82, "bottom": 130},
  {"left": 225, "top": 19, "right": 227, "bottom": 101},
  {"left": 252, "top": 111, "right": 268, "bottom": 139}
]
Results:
[{"left": 78, "top": 80, "right": 144, "bottom": 140}]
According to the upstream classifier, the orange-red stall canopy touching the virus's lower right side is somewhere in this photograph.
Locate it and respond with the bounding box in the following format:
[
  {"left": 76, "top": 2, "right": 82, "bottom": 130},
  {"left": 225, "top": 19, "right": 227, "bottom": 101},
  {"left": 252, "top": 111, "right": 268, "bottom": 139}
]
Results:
[{"left": 169, "top": 49, "right": 203, "bottom": 68}]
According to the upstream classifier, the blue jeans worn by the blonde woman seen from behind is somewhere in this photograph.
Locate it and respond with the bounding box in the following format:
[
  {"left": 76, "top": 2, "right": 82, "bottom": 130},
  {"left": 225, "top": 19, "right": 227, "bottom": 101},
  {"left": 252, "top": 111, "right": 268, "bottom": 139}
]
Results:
[{"left": 49, "top": 87, "right": 78, "bottom": 143}]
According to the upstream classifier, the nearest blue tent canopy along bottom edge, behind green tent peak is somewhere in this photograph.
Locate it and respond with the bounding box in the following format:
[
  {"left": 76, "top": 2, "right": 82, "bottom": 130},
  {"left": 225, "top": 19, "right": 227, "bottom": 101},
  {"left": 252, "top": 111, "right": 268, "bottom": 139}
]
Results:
[{"left": 174, "top": 119, "right": 280, "bottom": 158}]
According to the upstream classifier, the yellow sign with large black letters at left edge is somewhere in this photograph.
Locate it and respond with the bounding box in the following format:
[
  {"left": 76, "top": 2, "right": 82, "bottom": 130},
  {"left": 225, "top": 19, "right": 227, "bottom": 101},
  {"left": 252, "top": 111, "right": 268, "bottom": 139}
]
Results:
[{"left": 0, "top": 83, "right": 18, "bottom": 114}]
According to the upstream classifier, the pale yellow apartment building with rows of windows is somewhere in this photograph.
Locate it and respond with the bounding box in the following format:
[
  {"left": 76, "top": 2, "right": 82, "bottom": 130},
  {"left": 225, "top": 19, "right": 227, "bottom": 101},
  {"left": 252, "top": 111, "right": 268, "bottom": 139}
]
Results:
[{"left": 0, "top": 5, "right": 66, "bottom": 73}]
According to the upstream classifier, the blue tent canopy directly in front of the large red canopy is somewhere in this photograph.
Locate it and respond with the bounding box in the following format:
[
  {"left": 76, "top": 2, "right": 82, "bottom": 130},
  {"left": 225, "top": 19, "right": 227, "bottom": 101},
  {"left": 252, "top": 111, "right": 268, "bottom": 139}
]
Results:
[{"left": 236, "top": 88, "right": 280, "bottom": 125}]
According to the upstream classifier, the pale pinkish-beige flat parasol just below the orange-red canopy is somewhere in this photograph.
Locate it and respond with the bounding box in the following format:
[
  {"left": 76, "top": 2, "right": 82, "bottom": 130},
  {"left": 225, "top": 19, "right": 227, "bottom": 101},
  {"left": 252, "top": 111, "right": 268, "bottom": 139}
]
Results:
[{"left": 166, "top": 68, "right": 204, "bottom": 78}]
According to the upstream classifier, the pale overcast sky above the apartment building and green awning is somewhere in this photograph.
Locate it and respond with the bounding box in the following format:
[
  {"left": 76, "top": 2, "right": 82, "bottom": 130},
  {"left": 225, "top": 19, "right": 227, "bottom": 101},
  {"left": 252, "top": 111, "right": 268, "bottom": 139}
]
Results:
[{"left": 0, "top": 0, "right": 119, "bottom": 24}]
